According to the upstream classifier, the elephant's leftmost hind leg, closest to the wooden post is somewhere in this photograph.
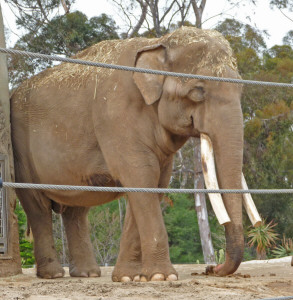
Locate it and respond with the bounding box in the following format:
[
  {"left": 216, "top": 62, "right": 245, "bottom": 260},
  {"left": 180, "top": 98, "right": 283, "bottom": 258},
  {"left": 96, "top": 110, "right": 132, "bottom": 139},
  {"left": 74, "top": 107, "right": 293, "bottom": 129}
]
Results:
[{"left": 17, "top": 190, "right": 64, "bottom": 279}]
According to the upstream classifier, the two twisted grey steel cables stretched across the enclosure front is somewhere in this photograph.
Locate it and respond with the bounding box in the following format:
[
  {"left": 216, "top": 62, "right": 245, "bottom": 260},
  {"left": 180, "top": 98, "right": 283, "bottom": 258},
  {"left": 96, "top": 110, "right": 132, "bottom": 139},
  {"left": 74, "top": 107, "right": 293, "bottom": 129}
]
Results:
[{"left": 0, "top": 48, "right": 293, "bottom": 194}]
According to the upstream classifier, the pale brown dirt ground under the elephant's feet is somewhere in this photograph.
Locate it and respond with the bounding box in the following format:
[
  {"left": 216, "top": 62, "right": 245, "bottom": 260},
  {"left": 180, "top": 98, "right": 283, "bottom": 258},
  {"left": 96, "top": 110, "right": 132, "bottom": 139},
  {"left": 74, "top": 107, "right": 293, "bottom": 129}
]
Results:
[{"left": 0, "top": 257, "right": 293, "bottom": 300}]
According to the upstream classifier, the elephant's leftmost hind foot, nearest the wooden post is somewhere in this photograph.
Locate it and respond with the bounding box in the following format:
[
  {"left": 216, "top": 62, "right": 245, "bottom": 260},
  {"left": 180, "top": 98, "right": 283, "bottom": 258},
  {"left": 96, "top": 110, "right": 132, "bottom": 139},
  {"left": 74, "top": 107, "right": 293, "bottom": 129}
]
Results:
[{"left": 37, "top": 258, "right": 65, "bottom": 279}]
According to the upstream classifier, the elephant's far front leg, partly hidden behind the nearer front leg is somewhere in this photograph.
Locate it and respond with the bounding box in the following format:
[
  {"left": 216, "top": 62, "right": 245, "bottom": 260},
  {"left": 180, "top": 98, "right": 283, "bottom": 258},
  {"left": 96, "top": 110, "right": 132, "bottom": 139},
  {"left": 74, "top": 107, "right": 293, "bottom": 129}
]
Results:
[{"left": 112, "top": 203, "right": 142, "bottom": 282}]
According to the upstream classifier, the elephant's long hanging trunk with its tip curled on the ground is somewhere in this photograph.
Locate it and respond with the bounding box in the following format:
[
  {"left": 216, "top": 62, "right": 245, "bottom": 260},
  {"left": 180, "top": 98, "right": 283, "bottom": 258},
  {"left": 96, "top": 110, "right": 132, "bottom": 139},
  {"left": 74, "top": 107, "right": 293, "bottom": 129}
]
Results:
[{"left": 211, "top": 112, "right": 244, "bottom": 276}]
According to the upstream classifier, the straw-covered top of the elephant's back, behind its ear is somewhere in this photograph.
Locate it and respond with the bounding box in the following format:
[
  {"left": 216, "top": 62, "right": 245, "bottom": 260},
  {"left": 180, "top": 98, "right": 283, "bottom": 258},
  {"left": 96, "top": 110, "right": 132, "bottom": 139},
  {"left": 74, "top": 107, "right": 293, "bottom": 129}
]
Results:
[{"left": 13, "top": 38, "right": 157, "bottom": 102}]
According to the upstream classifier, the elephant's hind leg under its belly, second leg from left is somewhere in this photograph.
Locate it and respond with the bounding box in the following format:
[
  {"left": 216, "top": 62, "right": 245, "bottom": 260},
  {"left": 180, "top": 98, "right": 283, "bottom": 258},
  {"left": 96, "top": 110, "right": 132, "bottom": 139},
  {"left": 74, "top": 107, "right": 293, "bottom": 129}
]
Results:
[{"left": 62, "top": 207, "right": 101, "bottom": 277}]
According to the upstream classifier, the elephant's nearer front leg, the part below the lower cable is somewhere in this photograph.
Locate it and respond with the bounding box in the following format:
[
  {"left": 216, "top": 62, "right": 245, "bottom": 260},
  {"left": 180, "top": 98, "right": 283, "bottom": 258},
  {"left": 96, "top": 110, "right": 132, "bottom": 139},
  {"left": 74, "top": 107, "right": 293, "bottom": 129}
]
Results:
[{"left": 128, "top": 193, "right": 178, "bottom": 281}]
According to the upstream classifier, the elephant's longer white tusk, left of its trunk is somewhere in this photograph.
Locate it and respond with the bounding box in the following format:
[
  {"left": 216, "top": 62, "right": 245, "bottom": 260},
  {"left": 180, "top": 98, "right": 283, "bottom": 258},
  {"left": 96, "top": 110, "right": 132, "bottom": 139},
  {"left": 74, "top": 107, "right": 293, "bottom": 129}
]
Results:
[{"left": 200, "top": 133, "right": 231, "bottom": 225}]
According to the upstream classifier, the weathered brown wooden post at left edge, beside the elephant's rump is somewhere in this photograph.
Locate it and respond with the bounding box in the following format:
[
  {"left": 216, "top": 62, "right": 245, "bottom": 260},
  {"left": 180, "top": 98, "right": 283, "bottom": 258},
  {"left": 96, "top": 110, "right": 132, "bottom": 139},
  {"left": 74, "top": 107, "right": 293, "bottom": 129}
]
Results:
[{"left": 0, "top": 5, "right": 22, "bottom": 277}]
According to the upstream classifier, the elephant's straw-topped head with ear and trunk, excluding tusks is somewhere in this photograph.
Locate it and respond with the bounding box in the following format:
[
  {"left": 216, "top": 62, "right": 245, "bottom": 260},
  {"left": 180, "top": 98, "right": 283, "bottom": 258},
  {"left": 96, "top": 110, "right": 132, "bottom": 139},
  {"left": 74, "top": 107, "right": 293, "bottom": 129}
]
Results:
[{"left": 133, "top": 27, "right": 250, "bottom": 275}]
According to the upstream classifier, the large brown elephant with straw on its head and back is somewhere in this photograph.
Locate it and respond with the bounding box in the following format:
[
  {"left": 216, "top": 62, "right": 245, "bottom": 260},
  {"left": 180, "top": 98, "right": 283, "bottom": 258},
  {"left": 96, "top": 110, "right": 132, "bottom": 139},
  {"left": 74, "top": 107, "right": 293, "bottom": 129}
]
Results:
[{"left": 11, "top": 27, "right": 244, "bottom": 282}]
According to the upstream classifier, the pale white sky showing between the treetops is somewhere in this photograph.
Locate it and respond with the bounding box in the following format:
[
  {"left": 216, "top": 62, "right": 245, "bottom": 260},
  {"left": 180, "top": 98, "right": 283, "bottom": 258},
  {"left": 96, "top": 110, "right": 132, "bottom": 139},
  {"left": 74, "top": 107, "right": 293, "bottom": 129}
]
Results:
[{"left": 0, "top": 0, "right": 293, "bottom": 47}]
